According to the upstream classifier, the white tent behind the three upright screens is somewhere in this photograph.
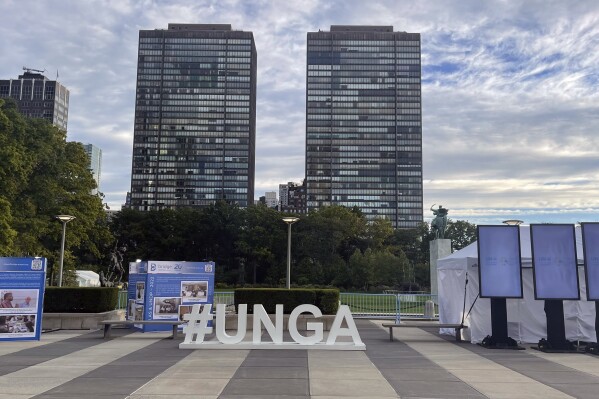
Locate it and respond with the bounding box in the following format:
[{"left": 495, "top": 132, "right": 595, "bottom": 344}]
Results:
[{"left": 438, "top": 226, "right": 597, "bottom": 343}]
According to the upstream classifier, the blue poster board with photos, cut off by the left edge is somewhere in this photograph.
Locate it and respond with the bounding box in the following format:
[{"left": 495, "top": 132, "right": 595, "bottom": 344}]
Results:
[{"left": 0, "top": 258, "right": 47, "bottom": 341}]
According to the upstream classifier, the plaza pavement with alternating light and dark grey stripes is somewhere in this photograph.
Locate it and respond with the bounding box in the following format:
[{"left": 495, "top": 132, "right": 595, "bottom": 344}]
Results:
[{"left": 0, "top": 320, "right": 599, "bottom": 399}]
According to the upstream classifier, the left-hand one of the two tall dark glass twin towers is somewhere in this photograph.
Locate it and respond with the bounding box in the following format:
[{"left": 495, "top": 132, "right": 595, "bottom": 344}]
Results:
[{"left": 130, "top": 24, "right": 257, "bottom": 210}]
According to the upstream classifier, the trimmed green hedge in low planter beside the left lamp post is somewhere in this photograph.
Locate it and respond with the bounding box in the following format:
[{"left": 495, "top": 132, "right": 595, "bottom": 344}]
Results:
[{"left": 44, "top": 287, "right": 119, "bottom": 313}]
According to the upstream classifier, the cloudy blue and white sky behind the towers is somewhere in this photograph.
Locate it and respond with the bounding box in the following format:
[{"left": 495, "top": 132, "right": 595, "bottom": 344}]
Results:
[{"left": 0, "top": 0, "right": 599, "bottom": 223}]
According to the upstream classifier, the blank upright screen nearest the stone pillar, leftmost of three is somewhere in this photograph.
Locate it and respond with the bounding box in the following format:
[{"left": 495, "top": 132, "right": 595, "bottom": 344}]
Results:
[{"left": 477, "top": 226, "right": 523, "bottom": 298}]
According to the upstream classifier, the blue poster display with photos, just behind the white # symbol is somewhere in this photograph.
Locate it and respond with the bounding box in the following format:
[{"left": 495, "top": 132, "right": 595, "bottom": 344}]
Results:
[{"left": 127, "top": 260, "right": 215, "bottom": 331}]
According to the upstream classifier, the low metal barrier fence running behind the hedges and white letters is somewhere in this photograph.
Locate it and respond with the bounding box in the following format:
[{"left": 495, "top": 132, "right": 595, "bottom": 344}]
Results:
[{"left": 117, "top": 290, "right": 439, "bottom": 321}]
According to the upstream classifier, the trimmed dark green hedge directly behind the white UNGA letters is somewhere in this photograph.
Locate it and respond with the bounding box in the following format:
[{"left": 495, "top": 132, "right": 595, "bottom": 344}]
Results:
[{"left": 235, "top": 288, "right": 339, "bottom": 314}]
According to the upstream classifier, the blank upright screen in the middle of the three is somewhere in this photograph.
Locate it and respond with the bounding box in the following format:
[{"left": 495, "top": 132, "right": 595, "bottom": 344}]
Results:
[{"left": 530, "top": 224, "right": 580, "bottom": 300}]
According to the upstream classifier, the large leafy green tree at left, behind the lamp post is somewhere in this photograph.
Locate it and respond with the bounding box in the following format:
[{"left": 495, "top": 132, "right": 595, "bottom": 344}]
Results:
[{"left": 0, "top": 99, "right": 113, "bottom": 282}]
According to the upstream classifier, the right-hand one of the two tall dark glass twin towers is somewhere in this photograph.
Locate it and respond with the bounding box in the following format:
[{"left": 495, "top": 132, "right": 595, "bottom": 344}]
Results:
[{"left": 306, "top": 25, "right": 423, "bottom": 228}]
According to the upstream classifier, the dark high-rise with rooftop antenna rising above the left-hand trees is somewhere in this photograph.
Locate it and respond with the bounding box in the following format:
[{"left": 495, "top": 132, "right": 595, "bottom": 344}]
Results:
[{"left": 0, "top": 68, "right": 69, "bottom": 131}]
